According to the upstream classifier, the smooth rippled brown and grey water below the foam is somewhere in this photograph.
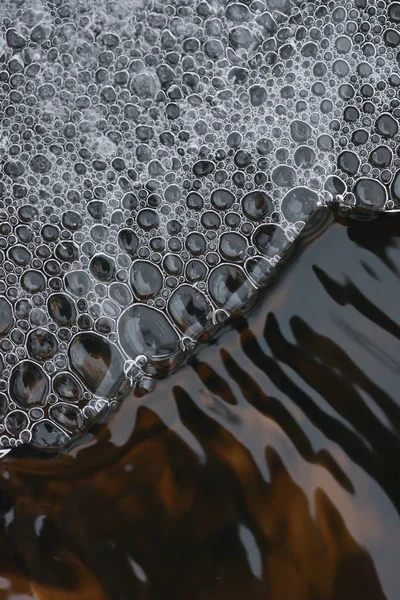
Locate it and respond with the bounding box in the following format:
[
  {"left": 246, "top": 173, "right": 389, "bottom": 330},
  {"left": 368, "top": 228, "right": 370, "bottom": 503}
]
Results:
[{"left": 0, "top": 215, "right": 400, "bottom": 600}]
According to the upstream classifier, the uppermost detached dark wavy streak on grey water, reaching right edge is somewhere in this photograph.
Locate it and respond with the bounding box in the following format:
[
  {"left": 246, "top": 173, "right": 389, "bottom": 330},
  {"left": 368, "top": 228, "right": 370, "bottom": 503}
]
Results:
[{"left": 313, "top": 265, "right": 400, "bottom": 340}]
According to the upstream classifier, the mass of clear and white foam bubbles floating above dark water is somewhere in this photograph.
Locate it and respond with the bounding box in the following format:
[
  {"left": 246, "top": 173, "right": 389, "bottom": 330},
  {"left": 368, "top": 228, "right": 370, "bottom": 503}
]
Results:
[{"left": 0, "top": 0, "right": 400, "bottom": 448}]
